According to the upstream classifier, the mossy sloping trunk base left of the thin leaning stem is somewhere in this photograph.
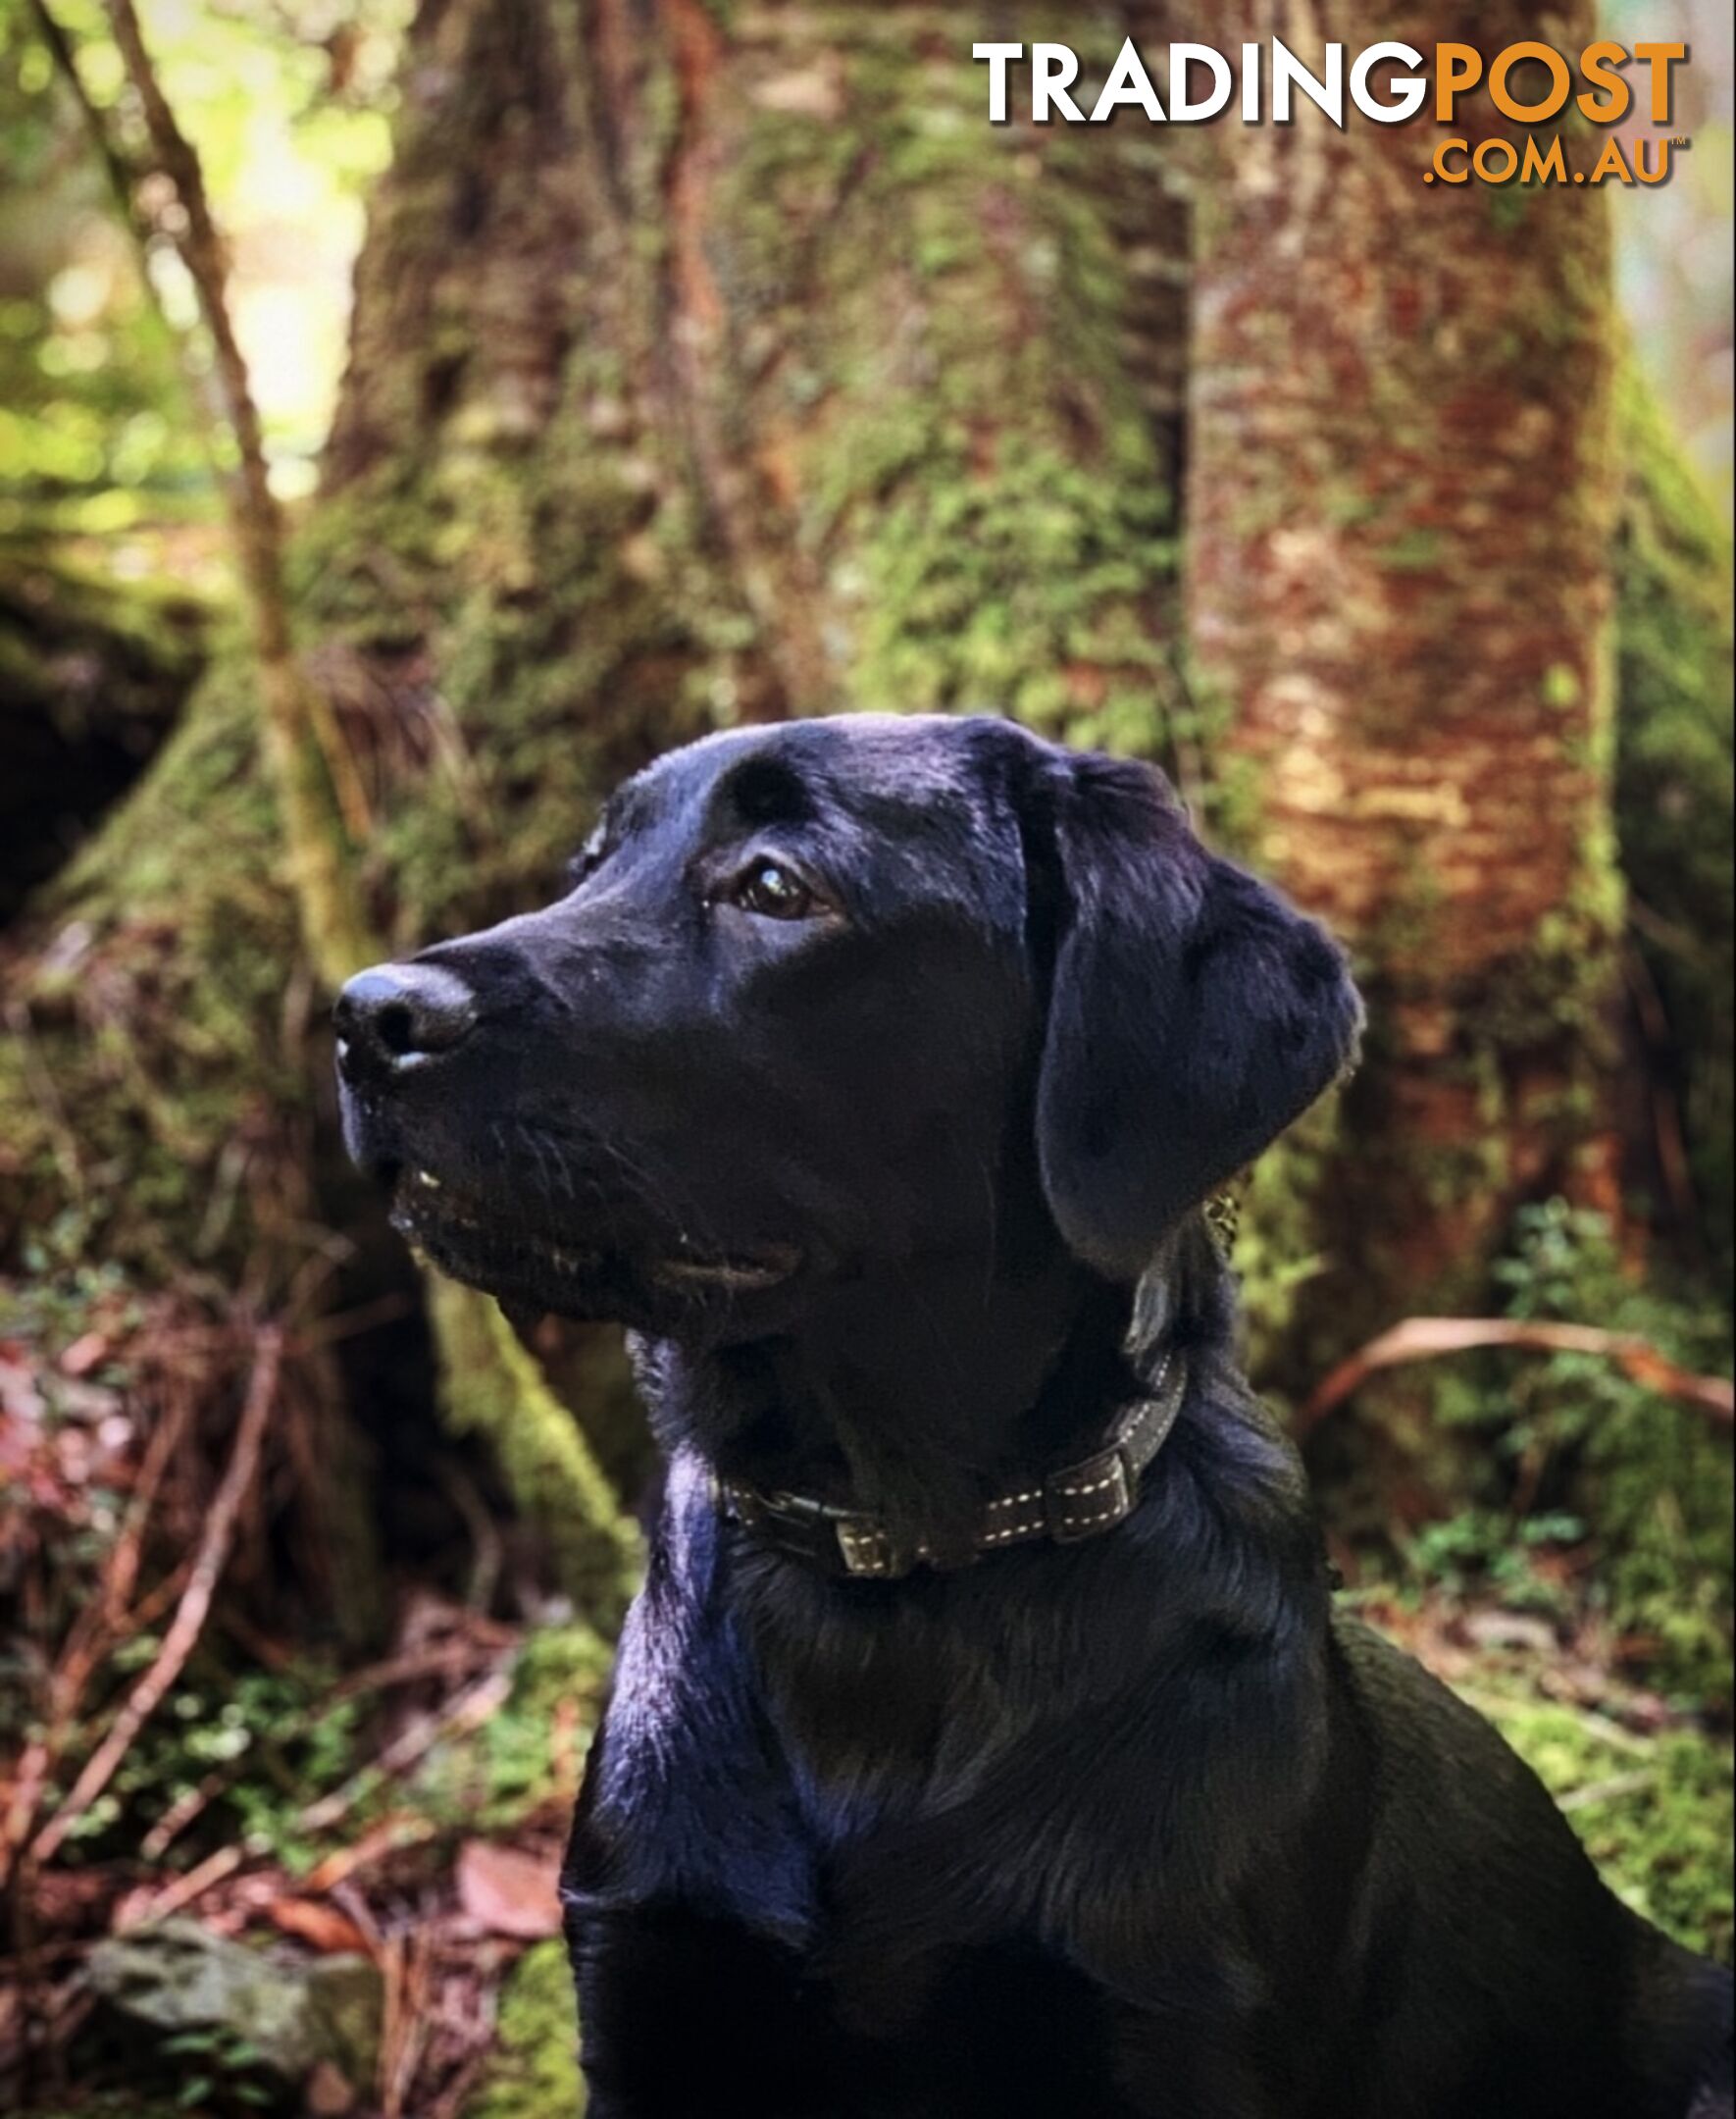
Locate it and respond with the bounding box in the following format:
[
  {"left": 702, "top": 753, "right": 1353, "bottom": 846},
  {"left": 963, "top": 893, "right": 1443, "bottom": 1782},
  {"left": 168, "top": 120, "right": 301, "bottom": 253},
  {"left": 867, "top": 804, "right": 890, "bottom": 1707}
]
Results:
[{"left": 0, "top": 652, "right": 307, "bottom": 1275}]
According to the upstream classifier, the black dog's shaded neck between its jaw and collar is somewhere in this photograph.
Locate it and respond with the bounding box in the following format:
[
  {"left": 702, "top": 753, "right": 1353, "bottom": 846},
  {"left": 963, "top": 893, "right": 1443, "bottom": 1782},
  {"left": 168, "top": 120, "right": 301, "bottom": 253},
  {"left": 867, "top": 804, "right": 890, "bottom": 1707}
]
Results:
[{"left": 650, "top": 1229, "right": 1225, "bottom": 1538}]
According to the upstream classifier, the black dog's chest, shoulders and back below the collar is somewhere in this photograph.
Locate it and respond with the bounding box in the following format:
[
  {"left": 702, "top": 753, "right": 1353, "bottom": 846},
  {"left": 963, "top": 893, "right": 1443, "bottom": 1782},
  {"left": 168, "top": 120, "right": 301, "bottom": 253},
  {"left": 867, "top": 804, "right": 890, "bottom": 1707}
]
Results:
[{"left": 566, "top": 1403, "right": 1727, "bottom": 2119}]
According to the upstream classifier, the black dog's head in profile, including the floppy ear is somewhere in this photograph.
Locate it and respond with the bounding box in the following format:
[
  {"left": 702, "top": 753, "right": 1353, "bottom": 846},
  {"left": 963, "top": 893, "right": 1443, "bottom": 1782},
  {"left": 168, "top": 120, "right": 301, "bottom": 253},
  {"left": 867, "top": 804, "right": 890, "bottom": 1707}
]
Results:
[{"left": 337, "top": 716, "right": 1358, "bottom": 1335}]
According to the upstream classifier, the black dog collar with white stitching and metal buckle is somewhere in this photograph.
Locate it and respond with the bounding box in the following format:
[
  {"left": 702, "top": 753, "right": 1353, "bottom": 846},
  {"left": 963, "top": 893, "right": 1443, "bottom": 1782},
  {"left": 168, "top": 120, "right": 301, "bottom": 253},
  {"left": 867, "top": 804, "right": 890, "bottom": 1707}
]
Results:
[{"left": 712, "top": 1354, "right": 1187, "bottom": 1580}]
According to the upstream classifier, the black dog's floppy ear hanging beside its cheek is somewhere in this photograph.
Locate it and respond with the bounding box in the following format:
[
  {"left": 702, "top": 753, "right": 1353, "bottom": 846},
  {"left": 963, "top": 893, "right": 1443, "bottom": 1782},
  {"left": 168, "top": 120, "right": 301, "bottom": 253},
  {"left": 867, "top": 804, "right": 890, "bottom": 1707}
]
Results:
[{"left": 1037, "top": 756, "right": 1360, "bottom": 1280}]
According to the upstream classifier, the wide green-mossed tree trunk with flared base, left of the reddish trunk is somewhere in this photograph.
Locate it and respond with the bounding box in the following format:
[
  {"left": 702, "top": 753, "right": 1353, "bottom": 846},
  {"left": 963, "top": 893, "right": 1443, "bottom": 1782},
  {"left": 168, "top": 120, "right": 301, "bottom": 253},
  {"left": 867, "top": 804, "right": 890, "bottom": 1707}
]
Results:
[{"left": 0, "top": 0, "right": 1187, "bottom": 1619}]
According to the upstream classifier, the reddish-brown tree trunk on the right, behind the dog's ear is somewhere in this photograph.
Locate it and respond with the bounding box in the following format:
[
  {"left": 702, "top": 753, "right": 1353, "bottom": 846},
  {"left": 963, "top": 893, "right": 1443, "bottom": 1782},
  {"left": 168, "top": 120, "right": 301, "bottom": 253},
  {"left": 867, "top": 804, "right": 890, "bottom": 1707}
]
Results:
[{"left": 1187, "top": 0, "right": 1621, "bottom": 1333}]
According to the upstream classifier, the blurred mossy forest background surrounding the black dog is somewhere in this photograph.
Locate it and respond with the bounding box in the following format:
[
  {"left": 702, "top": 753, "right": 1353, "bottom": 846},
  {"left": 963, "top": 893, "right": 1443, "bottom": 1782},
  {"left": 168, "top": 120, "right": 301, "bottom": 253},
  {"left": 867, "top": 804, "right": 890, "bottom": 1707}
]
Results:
[{"left": 0, "top": 0, "right": 1732, "bottom": 2119}]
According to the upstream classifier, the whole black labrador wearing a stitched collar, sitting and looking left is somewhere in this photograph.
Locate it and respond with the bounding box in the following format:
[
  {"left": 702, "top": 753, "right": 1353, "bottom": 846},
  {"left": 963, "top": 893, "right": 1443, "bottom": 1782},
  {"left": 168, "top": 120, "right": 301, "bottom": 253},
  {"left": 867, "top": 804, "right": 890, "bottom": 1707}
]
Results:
[{"left": 337, "top": 716, "right": 1730, "bottom": 2119}]
